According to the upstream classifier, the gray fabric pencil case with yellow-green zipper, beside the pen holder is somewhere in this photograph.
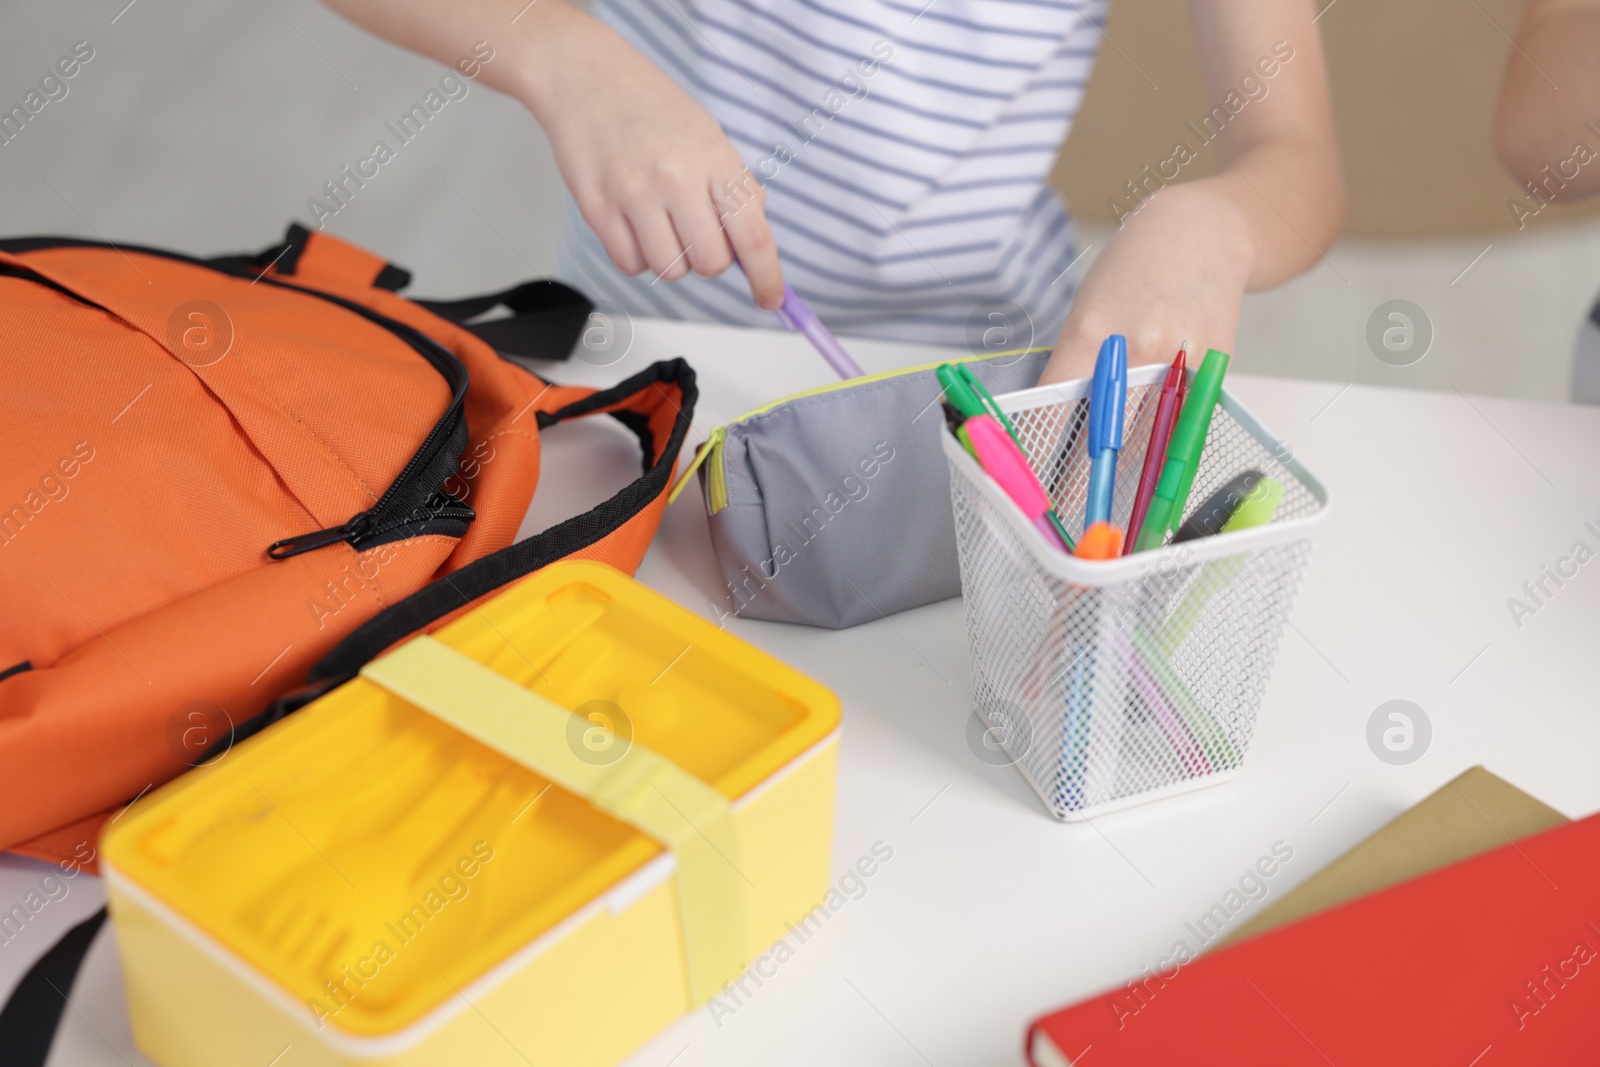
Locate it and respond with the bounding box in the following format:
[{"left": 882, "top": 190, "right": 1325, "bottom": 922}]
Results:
[{"left": 674, "top": 349, "right": 1050, "bottom": 629}]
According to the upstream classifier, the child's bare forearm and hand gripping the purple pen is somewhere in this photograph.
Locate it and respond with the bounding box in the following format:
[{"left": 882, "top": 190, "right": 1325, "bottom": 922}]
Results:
[{"left": 326, "top": 0, "right": 784, "bottom": 310}]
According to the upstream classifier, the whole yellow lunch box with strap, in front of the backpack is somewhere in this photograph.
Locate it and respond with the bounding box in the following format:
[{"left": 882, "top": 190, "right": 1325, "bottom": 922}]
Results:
[{"left": 101, "top": 561, "right": 838, "bottom": 1067}]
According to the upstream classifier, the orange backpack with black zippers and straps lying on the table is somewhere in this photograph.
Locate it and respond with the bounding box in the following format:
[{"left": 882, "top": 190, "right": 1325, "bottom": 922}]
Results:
[{"left": 0, "top": 227, "right": 696, "bottom": 862}]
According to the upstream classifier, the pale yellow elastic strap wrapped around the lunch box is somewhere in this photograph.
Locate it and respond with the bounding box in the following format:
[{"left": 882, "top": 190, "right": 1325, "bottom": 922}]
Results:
[{"left": 362, "top": 637, "right": 749, "bottom": 1006}]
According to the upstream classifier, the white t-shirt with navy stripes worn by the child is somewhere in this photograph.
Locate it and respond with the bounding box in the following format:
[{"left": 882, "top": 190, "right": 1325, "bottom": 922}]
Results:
[{"left": 560, "top": 0, "right": 1107, "bottom": 347}]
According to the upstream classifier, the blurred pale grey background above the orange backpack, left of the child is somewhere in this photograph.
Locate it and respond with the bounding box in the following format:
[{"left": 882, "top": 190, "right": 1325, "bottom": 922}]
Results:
[{"left": 0, "top": 0, "right": 562, "bottom": 296}]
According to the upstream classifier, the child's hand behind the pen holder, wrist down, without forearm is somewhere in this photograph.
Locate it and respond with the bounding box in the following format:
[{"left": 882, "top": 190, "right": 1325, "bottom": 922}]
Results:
[{"left": 1040, "top": 181, "right": 1254, "bottom": 382}]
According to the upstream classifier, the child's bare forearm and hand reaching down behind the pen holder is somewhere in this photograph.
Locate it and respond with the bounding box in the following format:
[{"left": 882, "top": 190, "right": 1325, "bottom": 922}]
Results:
[{"left": 1042, "top": 0, "right": 1344, "bottom": 382}]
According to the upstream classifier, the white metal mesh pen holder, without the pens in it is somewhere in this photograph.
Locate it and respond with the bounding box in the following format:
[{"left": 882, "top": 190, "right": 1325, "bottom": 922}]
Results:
[{"left": 944, "top": 365, "right": 1328, "bottom": 819}]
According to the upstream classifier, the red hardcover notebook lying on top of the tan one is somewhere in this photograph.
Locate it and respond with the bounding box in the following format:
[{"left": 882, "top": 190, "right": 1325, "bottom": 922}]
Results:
[{"left": 1027, "top": 816, "right": 1600, "bottom": 1067}]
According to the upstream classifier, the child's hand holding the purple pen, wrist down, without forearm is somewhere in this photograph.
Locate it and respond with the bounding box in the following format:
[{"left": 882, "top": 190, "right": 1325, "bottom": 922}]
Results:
[{"left": 517, "top": 5, "right": 784, "bottom": 310}]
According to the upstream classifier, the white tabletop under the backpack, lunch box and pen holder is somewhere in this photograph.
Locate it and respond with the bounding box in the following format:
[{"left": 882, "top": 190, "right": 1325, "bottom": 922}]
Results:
[{"left": 0, "top": 322, "right": 1600, "bottom": 1067}]
